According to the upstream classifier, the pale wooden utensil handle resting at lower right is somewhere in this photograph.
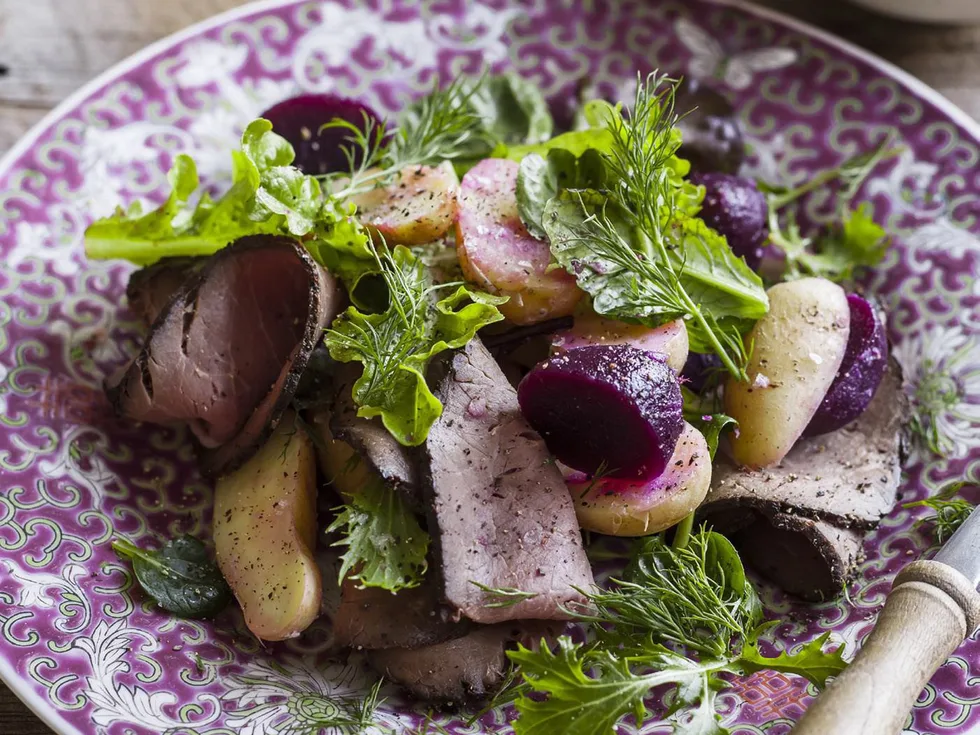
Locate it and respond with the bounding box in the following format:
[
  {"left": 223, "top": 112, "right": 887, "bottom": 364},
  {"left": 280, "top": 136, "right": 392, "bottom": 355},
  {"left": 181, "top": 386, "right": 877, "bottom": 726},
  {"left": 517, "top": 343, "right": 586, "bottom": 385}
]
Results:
[{"left": 793, "top": 561, "right": 980, "bottom": 735}]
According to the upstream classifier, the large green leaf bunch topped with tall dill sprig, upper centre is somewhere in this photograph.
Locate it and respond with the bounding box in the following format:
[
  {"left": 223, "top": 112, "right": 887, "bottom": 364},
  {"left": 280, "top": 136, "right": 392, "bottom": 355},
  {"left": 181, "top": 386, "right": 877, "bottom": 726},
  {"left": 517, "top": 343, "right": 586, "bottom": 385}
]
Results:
[{"left": 518, "top": 74, "right": 768, "bottom": 379}]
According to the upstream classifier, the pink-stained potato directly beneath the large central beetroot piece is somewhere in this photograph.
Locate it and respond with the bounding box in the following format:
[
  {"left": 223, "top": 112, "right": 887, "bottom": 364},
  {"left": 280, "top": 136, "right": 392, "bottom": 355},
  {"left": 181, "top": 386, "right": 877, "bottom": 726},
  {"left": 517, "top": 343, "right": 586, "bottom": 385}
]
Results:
[{"left": 562, "top": 423, "right": 711, "bottom": 536}]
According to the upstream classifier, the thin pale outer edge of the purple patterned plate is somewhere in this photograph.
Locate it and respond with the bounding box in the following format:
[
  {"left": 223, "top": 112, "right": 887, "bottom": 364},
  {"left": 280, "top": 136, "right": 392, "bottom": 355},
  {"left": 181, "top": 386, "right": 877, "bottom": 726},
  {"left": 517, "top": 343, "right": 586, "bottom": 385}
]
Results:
[{"left": 0, "top": 0, "right": 980, "bottom": 735}]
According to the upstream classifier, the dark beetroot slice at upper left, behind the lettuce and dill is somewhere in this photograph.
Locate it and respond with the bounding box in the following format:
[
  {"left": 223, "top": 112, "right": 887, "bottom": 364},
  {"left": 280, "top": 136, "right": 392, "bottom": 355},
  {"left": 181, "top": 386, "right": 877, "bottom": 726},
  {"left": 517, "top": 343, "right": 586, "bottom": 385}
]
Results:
[{"left": 262, "top": 94, "right": 381, "bottom": 175}]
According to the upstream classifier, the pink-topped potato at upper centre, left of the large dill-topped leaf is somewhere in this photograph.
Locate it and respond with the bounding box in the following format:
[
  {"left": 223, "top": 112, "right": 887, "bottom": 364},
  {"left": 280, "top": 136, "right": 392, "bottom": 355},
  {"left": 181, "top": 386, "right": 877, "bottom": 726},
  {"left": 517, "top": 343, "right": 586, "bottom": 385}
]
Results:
[{"left": 456, "top": 158, "right": 582, "bottom": 324}]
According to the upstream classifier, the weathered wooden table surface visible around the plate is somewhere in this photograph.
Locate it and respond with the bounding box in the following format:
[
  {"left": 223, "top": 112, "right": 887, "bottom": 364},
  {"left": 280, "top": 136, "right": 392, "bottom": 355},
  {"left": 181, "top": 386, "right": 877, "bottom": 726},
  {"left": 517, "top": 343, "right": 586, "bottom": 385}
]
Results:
[{"left": 0, "top": 0, "right": 980, "bottom": 735}]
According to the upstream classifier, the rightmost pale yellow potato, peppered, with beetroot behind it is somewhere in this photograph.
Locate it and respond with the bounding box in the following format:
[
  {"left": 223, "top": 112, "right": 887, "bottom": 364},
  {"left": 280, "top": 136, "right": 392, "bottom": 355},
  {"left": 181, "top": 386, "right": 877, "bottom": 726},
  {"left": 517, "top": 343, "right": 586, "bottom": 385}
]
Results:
[{"left": 725, "top": 278, "right": 851, "bottom": 469}]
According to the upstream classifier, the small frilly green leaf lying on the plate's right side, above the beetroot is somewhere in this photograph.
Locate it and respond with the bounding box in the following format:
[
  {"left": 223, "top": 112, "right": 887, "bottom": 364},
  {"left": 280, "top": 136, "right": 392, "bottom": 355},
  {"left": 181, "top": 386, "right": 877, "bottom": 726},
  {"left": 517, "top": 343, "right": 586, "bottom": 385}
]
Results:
[{"left": 770, "top": 204, "right": 890, "bottom": 282}]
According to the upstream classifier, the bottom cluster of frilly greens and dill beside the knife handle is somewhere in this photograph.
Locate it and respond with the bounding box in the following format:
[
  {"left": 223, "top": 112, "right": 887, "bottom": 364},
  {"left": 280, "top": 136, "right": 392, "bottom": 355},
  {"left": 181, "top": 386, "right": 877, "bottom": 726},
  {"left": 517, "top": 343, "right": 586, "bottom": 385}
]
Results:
[{"left": 508, "top": 529, "right": 846, "bottom": 735}]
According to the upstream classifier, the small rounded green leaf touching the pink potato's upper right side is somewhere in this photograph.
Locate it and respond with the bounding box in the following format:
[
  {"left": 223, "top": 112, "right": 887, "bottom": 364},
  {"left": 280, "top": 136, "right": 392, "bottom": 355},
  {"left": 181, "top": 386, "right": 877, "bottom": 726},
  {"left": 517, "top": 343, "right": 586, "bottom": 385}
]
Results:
[{"left": 517, "top": 148, "right": 606, "bottom": 240}]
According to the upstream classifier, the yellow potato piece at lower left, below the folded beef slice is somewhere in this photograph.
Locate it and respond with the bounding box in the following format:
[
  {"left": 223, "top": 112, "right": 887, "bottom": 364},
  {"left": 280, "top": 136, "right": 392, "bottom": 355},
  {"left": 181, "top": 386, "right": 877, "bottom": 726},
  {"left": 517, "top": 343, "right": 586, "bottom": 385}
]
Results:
[{"left": 214, "top": 415, "right": 322, "bottom": 641}]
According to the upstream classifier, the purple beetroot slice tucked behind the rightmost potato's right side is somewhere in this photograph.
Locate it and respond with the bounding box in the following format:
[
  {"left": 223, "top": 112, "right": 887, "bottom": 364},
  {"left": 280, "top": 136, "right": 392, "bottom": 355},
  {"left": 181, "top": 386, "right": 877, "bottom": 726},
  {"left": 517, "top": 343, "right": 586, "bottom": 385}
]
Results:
[{"left": 803, "top": 294, "right": 888, "bottom": 436}]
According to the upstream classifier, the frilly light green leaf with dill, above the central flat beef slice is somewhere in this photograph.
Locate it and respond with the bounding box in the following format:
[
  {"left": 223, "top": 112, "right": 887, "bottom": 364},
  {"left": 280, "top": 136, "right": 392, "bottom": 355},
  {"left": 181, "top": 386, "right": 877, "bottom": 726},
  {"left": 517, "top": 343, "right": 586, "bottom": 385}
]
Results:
[{"left": 326, "top": 246, "right": 506, "bottom": 446}]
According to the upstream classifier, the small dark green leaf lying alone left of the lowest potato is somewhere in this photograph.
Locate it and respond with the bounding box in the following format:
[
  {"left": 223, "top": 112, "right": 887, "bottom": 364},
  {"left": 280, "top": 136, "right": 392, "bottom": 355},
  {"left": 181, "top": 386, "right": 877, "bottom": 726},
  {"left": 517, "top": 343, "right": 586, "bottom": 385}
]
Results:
[{"left": 112, "top": 535, "right": 231, "bottom": 619}]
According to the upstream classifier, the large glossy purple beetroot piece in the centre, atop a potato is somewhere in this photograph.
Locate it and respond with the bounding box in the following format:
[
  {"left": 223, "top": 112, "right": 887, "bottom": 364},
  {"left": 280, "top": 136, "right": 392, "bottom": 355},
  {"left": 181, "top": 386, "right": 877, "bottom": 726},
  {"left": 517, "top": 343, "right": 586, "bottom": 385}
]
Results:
[{"left": 518, "top": 345, "right": 684, "bottom": 479}]
